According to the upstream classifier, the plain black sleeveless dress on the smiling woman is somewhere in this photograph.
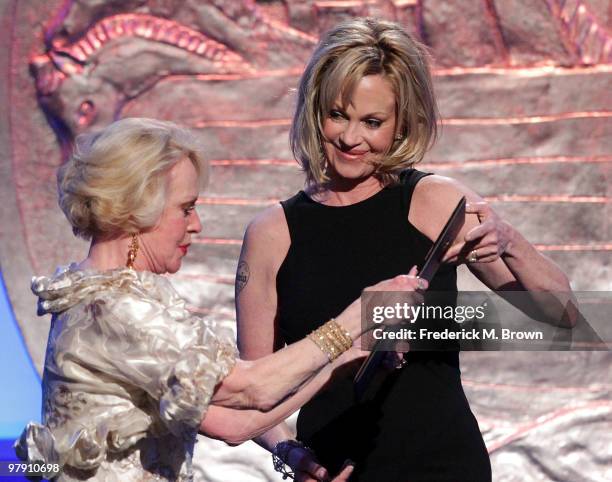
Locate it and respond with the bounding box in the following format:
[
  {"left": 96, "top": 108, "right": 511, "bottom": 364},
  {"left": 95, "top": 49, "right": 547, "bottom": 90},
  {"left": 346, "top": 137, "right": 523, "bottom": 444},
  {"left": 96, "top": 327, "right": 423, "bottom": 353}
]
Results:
[{"left": 276, "top": 169, "right": 491, "bottom": 482}]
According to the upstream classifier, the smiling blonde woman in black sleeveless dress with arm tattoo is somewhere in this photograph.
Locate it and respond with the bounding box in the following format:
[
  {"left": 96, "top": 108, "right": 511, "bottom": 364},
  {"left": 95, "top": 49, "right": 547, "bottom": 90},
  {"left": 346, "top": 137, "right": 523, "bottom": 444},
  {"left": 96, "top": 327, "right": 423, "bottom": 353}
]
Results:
[{"left": 236, "top": 19, "right": 571, "bottom": 482}]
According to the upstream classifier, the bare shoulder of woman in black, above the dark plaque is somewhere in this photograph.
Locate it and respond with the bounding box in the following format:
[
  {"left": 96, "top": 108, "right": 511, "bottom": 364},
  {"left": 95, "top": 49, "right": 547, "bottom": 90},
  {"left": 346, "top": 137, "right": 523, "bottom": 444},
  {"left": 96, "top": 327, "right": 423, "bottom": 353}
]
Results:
[{"left": 408, "top": 174, "right": 482, "bottom": 240}]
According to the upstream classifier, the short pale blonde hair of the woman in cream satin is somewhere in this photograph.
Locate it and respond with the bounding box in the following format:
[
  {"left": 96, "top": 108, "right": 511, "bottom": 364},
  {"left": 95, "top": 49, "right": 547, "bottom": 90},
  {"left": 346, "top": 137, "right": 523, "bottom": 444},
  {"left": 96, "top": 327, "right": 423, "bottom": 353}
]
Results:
[{"left": 57, "top": 118, "right": 208, "bottom": 239}]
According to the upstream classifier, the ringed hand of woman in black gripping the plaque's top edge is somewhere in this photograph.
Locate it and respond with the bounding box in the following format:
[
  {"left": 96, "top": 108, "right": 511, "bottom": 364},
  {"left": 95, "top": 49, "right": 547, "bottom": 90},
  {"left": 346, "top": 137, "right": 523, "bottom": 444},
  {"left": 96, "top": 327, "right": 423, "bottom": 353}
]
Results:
[{"left": 442, "top": 201, "right": 514, "bottom": 264}]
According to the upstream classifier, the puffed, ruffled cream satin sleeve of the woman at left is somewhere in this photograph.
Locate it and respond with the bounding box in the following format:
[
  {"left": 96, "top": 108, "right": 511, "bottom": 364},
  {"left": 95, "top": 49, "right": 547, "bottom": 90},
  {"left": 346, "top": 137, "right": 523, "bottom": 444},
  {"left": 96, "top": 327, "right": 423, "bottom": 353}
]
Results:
[{"left": 88, "top": 279, "right": 237, "bottom": 436}]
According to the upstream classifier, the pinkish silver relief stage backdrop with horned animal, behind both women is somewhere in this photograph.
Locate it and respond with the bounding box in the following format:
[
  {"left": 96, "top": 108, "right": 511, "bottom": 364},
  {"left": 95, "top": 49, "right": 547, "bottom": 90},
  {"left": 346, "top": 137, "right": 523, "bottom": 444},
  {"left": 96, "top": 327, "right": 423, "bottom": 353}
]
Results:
[{"left": 0, "top": 0, "right": 612, "bottom": 482}]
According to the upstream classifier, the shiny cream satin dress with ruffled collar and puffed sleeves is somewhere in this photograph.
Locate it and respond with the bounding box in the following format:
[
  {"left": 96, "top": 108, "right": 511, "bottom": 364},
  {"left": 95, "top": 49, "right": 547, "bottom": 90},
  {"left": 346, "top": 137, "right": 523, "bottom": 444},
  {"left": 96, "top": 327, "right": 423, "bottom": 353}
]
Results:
[{"left": 15, "top": 265, "right": 237, "bottom": 482}]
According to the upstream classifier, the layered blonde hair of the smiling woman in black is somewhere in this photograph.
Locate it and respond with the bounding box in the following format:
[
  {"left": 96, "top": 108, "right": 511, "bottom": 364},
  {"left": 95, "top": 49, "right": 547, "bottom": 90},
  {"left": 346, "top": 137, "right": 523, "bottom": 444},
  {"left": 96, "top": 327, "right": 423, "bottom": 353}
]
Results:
[{"left": 290, "top": 18, "right": 439, "bottom": 187}]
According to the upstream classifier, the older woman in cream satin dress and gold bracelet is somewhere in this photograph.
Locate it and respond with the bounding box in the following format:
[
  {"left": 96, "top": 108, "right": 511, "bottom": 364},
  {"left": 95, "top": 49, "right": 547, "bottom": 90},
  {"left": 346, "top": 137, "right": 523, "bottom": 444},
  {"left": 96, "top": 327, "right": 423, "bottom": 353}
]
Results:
[{"left": 16, "top": 119, "right": 424, "bottom": 481}]
